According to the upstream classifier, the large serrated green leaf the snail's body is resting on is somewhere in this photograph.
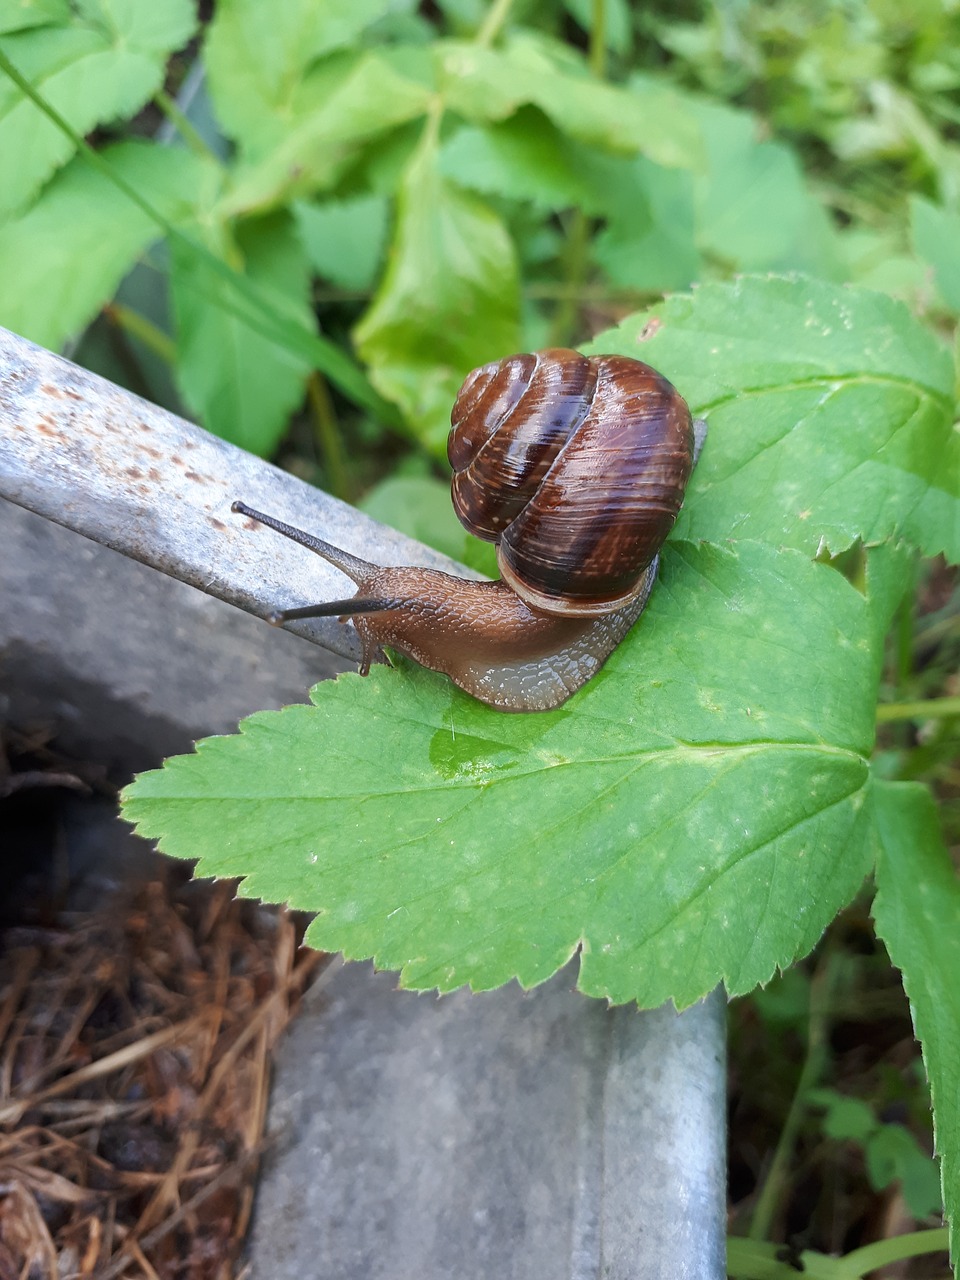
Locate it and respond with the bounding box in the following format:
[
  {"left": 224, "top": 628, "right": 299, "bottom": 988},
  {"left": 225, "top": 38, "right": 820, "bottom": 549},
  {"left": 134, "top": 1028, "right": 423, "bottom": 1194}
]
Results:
[{"left": 125, "top": 543, "right": 891, "bottom": 1006}]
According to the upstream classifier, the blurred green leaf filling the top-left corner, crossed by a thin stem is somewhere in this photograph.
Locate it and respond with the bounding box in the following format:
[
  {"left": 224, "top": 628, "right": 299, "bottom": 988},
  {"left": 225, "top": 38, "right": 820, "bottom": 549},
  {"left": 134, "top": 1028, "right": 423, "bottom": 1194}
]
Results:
[{"left": 0, "top": 0, "right": 197, "bottom": 214}]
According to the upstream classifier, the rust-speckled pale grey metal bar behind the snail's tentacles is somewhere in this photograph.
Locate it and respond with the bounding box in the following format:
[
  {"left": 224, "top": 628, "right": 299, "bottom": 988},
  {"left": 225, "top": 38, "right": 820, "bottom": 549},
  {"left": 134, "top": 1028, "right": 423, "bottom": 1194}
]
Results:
[{"left": 0, "top": 329, "right": 476, "bottom": 658}]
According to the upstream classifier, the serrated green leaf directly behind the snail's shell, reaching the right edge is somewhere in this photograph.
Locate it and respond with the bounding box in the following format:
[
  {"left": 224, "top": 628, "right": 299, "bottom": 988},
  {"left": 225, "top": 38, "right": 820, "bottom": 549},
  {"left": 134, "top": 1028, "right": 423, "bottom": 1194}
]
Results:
[{"left": 586, "top": 276, "right": 960, "bottom": 561}]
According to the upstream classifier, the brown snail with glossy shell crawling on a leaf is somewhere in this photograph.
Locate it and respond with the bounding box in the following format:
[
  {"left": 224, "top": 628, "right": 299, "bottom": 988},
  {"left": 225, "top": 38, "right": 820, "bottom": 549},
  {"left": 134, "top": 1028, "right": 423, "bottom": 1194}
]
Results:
[{"left": 232, "top": 348, "right": 707, "bottom": 712}]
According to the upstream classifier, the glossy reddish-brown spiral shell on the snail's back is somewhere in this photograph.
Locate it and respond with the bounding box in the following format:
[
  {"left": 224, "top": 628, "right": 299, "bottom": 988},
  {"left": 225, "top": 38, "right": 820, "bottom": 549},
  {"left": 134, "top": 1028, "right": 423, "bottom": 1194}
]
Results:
[{"left": 447, "top": 348, "right": 694, "bottom": 616}]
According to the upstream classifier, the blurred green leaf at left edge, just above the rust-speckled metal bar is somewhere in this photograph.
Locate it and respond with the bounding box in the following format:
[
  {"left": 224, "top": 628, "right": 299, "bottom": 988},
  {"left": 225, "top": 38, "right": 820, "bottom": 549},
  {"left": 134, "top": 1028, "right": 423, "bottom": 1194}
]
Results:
[{"left": 0, "top": 142, "right": 210, "bottom": 351}]
